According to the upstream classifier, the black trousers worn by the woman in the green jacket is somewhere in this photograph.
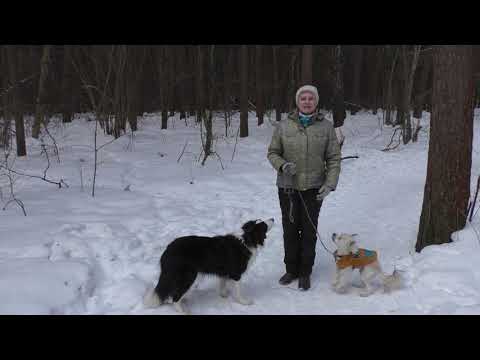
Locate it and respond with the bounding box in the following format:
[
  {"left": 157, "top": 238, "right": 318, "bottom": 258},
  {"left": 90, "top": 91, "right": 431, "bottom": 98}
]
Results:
[{"left": 278, "top": 188, "right": 322, "bottom": 276}]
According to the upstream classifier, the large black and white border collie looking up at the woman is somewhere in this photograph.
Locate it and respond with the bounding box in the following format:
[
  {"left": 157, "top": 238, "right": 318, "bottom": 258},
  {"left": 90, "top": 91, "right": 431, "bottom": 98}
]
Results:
[{"left": 143, "top": 219, "right": 274, "bottom": 314}]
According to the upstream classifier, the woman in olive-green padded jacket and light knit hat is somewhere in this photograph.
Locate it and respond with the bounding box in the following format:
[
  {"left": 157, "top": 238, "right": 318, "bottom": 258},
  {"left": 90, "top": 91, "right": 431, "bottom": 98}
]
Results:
[{"left": 267, "top": 85, "right": 341, "bottom": 290}]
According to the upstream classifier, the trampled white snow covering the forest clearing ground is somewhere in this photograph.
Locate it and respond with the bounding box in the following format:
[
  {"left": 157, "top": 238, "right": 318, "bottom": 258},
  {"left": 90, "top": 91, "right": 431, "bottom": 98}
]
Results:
[{"left": 0, "top": 110, "right": 480, "bottom": 315}]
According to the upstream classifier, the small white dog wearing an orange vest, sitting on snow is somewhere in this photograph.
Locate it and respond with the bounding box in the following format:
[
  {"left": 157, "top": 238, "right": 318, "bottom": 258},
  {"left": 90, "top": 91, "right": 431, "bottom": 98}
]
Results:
[{"left": 332, "top": 233, "right": 401, "bottom": 296}]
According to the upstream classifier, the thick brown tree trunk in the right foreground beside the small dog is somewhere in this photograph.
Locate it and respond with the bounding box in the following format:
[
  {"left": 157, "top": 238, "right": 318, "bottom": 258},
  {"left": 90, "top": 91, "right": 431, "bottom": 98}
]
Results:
[{"left": 415, "top": 45, "right": 474, "bottom": 252}]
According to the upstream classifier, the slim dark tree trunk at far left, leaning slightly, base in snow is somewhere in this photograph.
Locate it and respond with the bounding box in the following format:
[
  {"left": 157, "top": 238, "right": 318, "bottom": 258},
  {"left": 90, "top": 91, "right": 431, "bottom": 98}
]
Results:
[{"left": 7, "top": 45, "right": 27, "bottom": 156}]
